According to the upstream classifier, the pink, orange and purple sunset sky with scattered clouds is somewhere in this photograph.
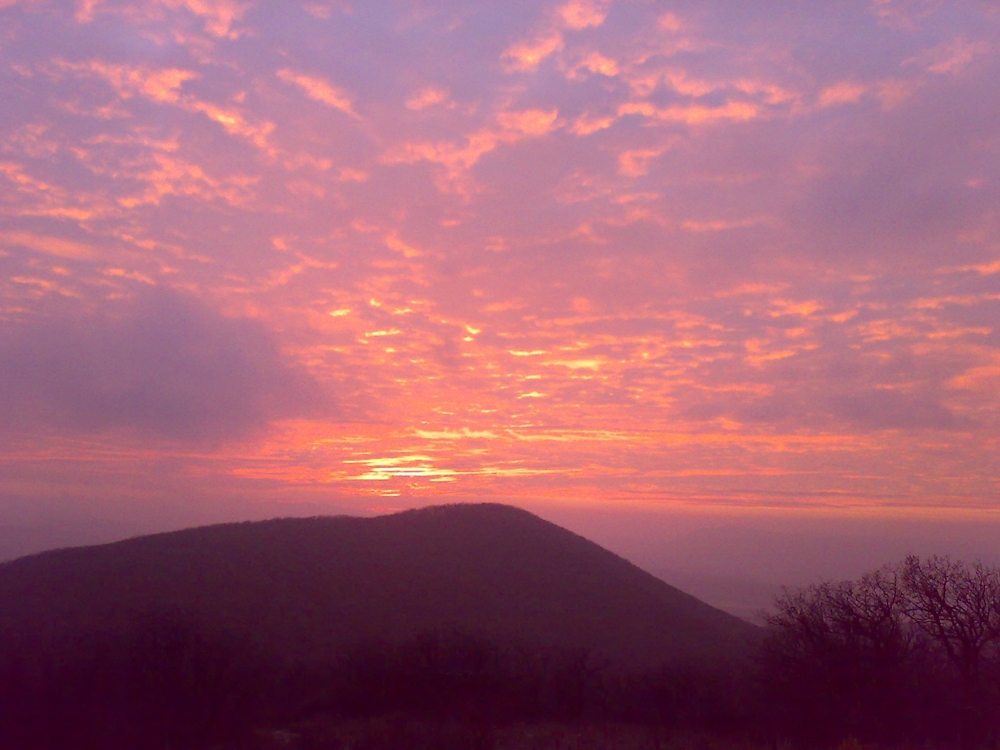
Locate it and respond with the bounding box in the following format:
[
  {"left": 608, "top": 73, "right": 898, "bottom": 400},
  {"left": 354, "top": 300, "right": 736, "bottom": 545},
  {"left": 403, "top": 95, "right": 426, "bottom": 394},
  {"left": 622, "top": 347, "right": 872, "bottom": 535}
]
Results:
[{"left": 0, "top": 0, "right": 1000, "bottom": 592}]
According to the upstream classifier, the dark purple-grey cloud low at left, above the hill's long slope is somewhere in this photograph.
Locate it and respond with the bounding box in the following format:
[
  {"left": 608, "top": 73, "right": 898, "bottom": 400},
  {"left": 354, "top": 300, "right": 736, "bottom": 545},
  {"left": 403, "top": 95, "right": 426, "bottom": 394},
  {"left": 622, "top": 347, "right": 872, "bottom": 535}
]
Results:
[{"left": 0, "top": 289, "right": 330, "bottom": 443}]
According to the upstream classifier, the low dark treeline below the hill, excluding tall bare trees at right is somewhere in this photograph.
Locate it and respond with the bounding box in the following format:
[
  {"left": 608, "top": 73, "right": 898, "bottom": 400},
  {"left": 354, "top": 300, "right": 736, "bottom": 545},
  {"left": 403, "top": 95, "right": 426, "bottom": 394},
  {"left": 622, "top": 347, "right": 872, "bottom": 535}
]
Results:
[{"left": 0, "top": 616, "right": 745, "bottom": 750}]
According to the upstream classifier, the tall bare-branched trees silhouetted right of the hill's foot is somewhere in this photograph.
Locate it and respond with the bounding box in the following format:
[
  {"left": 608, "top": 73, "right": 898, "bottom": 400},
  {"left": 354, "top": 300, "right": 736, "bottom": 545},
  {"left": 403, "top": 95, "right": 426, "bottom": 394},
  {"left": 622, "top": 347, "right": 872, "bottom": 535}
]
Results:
[{"left": 758, "top": 556, "right": 1000, "bottom": 748}]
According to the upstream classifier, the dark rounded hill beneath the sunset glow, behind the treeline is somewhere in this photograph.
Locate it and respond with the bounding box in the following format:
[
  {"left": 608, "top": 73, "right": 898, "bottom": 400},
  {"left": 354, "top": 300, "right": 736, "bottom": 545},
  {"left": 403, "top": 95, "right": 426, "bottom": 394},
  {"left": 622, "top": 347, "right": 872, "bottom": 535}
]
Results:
[{"left": 0, "top": 505, "right": 756, "bottom": 669}]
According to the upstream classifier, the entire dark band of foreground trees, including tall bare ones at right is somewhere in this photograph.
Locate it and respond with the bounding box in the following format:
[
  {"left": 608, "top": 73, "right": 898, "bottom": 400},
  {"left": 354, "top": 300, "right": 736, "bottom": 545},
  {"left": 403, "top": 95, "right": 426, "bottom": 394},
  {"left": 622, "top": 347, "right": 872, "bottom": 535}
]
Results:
[{"left": 0, "top": 557, "right": 1000, "bottom": 750}]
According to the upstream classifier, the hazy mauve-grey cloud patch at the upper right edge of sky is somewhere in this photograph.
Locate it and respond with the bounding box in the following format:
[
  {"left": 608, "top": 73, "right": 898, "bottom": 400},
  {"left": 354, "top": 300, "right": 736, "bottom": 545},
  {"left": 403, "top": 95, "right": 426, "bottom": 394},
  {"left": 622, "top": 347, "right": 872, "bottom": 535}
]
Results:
[{"left": 789, "top": 61, "right": 1000, "bottom": 264}]
